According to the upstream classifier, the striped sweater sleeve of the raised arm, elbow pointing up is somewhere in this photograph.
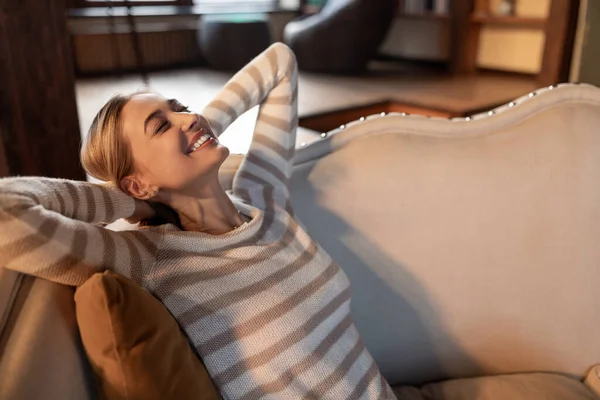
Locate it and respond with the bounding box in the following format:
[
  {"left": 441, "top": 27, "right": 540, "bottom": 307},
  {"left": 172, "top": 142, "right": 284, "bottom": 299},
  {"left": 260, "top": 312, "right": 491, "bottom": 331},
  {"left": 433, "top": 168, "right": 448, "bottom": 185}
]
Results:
[{"left": 203, "top": 43, "right": 298, "bottom": 211}]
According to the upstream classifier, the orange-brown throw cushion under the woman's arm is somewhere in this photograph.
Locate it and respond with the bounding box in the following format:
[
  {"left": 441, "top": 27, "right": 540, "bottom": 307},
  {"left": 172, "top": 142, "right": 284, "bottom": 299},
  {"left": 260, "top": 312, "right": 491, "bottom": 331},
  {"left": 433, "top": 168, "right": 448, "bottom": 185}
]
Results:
[{"left": 75, "top": 271, "right": 220, "bottom": 400}]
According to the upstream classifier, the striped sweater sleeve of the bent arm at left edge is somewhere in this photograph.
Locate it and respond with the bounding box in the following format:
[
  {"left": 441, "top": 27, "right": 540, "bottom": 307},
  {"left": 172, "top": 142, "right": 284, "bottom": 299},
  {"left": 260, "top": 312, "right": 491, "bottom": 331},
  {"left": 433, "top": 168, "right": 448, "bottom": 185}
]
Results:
[{"left": 0, "top": 177, "right": 159, "bottom": 286}]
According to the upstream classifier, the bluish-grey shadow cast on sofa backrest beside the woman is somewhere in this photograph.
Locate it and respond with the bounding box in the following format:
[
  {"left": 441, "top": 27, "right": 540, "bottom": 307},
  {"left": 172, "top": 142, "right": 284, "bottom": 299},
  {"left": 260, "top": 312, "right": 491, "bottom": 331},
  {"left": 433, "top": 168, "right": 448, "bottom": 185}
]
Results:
[{"left": 292, "top": 158, "right": 482, "bottom": 386}]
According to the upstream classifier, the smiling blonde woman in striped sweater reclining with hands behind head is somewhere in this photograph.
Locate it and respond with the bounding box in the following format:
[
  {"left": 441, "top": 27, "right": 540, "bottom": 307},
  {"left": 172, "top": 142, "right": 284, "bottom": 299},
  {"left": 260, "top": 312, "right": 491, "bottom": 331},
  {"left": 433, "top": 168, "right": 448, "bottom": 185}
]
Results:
[{"left": 0, "top": 44, "right": 394, "bottom": 400}]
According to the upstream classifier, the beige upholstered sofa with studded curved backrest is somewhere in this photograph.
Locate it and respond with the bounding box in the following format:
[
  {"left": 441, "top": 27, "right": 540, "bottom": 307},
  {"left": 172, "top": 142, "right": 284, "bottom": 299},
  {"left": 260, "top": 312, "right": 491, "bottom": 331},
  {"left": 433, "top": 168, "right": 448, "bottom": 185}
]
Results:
[{"left": 0, "top": 84, "right": 600, "bottom": 400}]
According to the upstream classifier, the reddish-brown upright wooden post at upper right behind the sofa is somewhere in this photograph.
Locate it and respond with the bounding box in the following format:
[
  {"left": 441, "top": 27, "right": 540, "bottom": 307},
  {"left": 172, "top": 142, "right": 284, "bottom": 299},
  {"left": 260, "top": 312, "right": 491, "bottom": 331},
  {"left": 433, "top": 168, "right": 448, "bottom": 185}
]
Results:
[{"left": 538, "top": 0, "right": 579, "bottom": 85}]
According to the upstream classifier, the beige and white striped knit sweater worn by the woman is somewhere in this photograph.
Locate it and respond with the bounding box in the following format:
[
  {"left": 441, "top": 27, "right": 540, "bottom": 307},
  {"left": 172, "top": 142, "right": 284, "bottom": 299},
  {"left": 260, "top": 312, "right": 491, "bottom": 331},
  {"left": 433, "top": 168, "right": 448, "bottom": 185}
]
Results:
[{"left": 0, "top": 44, "right": 395, "bottom": 400}]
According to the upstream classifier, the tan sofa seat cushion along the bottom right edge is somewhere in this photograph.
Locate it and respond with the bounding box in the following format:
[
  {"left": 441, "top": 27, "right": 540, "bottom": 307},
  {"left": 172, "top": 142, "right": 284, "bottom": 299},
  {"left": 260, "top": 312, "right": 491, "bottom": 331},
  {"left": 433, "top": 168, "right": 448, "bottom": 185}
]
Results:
[{"left": 394, "top": 373, "right": 599, "bottom": 400}]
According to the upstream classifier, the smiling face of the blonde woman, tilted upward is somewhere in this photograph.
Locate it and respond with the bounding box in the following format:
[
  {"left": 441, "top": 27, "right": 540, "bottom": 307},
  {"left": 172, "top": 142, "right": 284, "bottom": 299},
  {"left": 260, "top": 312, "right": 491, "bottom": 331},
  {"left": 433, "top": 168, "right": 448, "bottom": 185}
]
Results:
[{"left": 121, "top": 93, "right": 229, "bottom": 191}]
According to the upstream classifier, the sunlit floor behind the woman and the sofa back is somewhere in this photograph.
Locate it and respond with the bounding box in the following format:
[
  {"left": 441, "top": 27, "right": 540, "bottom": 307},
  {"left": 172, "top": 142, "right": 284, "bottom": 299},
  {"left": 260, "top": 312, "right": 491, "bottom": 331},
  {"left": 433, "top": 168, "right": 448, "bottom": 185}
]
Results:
[{"left": 76, "top": 69, "right": 538, "bottom": 153}]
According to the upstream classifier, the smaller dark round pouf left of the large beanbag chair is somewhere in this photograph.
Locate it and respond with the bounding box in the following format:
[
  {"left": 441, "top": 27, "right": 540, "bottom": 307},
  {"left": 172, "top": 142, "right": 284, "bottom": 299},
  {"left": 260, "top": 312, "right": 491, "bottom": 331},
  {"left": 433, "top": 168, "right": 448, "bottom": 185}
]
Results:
[{"left": 198, "top": 13, "right": 271, "bottom": 71}]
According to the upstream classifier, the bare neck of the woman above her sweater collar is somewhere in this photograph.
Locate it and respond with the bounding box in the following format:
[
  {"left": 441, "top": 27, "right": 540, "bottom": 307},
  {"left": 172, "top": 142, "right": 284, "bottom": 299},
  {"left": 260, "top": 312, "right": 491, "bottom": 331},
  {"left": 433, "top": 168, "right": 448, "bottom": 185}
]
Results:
[{"left": 159, "top": 179, "right": 244, "bottom": 235}]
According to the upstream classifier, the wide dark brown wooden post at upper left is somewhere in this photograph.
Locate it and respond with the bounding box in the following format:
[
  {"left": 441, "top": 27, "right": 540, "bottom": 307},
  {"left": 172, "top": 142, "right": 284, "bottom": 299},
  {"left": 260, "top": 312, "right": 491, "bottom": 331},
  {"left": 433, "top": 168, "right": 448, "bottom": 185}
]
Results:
[{"left": 0, "top": 0, "right": 85, "bottom": 179}]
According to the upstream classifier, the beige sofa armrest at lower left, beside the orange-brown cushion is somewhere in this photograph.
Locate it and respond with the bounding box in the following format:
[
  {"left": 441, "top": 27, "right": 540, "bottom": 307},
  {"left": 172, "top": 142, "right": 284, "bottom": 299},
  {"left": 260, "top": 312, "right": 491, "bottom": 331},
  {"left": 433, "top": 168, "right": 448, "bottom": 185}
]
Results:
[{"left": 0, "top": 267, "right": 97, "bottom": 400}]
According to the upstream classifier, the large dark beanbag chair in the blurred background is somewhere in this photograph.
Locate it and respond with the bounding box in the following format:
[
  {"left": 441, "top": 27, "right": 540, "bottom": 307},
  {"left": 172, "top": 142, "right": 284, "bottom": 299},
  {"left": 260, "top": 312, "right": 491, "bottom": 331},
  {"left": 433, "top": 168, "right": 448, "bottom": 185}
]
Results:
[{"left": 284, "top": 0, "right": 398, "bottom": 73}]
